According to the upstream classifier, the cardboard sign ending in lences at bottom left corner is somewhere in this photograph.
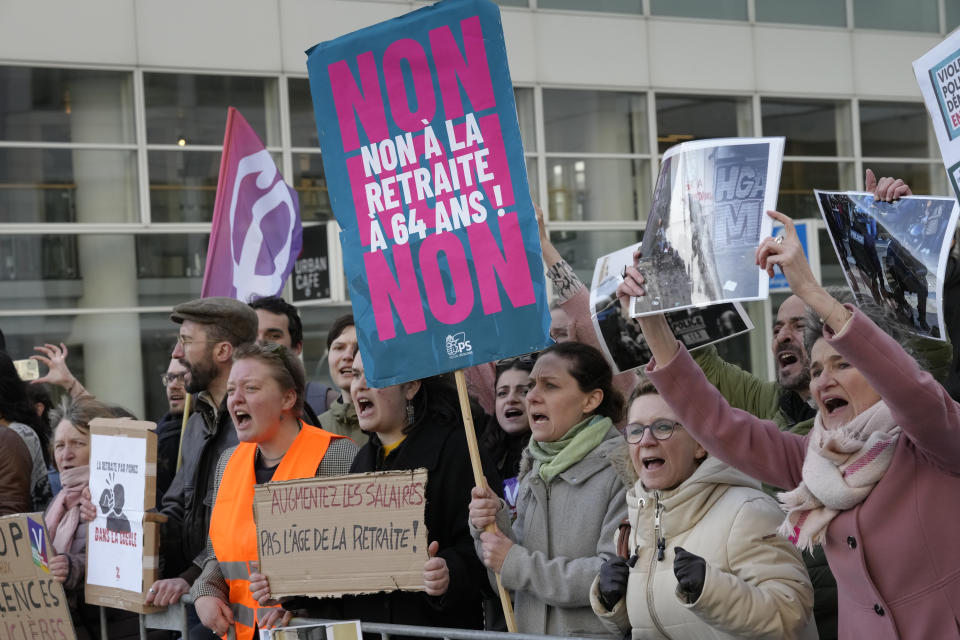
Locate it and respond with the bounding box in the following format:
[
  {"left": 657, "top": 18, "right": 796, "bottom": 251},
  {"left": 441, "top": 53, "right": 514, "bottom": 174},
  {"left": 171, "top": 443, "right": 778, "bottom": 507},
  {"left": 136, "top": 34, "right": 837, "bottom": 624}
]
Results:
[{"left": 0, "top": 513, "right": 76, "bottom": 640}]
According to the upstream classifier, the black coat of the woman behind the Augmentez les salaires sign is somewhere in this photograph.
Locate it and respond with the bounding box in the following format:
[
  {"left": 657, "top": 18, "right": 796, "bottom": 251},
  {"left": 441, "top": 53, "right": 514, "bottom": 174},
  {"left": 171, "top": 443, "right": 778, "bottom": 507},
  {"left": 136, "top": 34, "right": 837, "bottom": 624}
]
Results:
[{"left": 294, "top": 416, "right": 501, "bottom": 629}]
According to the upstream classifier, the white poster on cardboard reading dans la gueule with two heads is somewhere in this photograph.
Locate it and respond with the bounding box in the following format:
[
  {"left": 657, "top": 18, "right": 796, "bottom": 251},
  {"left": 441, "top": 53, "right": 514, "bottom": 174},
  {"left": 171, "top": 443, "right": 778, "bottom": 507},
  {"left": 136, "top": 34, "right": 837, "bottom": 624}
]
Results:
[{"left": 85, "top": 418, "right": 166, "bottom": 613}]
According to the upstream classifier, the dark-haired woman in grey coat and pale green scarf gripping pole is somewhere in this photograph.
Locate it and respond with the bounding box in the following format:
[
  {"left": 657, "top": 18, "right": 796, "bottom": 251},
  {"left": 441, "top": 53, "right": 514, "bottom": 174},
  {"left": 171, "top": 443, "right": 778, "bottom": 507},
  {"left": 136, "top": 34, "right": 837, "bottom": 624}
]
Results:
[{"left": 470, "top": 342, "right": 632, "bottom": 637}]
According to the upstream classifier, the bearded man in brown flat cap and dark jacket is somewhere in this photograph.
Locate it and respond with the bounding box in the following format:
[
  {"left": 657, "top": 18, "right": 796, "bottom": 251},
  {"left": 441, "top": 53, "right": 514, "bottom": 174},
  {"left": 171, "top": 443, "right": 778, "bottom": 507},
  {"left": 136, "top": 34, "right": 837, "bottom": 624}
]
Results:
[{"left": 147, "top": 297, "right": 257, "bottom": 606}]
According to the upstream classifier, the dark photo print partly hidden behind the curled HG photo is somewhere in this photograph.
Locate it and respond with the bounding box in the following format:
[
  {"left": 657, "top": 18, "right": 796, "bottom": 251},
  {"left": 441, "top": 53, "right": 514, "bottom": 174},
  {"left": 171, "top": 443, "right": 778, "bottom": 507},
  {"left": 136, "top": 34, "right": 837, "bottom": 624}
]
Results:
[{"left": 590, "top": 245, "right": 753, "bottom": 373}]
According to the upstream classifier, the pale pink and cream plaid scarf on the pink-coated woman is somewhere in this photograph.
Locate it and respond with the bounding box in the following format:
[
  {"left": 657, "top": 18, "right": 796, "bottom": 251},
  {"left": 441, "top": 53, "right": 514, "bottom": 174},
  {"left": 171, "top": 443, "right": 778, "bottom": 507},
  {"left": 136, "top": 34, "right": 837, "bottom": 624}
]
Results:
[{"left": 777, "top": 400, "right": 900, "bottom": 550}]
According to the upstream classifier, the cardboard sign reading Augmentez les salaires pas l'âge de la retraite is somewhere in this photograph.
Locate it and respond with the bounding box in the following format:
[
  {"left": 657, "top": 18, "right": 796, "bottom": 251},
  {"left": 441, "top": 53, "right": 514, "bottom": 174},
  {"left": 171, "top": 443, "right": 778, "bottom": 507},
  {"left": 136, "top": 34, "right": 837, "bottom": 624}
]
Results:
[{"left": 253, "top": 469, "right": 427, "bottom": 597}]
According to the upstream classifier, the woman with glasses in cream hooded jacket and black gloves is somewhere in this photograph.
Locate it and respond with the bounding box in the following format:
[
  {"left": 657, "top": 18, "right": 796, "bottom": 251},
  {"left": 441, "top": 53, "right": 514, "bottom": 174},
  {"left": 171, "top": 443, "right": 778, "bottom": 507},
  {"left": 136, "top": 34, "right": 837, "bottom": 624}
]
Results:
[{"left": 590, "top": 381, "right": 817, "bottom": 639}]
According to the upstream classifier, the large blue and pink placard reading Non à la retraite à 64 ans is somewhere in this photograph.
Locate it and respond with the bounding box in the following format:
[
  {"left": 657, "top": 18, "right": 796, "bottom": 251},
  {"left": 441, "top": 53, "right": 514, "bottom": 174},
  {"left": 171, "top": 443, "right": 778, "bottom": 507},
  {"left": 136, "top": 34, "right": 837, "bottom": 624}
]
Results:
[{"left": 307, "top": 0, "right": 551, "bottom": 387}]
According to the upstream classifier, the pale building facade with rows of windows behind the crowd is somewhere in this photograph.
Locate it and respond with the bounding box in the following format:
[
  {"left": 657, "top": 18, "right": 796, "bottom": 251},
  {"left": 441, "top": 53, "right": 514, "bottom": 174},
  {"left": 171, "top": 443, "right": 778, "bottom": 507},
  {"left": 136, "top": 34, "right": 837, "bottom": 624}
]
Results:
[{"left": 0, "top": 0, "right": 944, "bottom": 419}]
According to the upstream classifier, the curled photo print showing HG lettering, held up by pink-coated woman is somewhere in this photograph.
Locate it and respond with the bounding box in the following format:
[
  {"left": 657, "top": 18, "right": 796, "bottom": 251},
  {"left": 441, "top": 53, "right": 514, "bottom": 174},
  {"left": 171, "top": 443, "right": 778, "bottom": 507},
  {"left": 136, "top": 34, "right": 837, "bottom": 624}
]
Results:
[{"left": 630, "top": 138, "right": 783, "bottom": 316}]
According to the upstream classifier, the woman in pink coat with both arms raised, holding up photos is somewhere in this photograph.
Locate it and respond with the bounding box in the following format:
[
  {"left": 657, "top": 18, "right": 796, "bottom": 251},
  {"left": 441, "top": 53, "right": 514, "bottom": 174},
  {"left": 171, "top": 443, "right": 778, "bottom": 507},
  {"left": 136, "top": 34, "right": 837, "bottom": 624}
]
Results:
[{"left": 618, "top": 212, "right": 960, "bottom": 640}]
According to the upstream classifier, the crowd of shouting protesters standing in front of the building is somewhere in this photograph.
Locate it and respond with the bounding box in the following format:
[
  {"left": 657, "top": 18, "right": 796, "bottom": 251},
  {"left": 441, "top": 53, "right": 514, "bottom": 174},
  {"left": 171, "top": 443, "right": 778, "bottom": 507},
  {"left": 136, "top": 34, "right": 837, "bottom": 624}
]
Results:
[{"left": 0, "top": 173, "right": 960, "bottom": 640}]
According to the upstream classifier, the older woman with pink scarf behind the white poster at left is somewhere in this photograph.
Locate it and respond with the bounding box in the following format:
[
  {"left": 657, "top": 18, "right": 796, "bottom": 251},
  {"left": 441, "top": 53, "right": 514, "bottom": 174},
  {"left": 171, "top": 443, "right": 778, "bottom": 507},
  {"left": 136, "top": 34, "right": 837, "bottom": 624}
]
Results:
[{"left": 43, "top": 396, "right": 113, "bottom": 638}]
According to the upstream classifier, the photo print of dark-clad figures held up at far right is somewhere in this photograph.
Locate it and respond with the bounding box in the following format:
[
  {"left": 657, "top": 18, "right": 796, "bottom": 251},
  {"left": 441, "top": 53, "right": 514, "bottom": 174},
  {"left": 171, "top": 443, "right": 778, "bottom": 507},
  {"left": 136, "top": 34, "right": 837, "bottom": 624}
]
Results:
[{"left": 814, "top": 190, "right": 960, "bottom": 340}]
